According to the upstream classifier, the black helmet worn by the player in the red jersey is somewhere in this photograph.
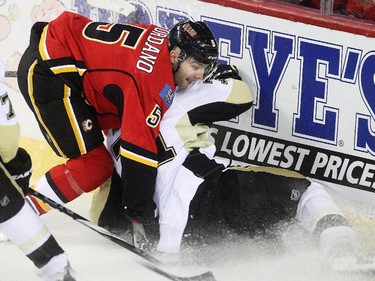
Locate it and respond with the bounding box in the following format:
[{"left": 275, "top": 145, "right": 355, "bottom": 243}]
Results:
[{"left": 168, "top": 21, "right": 219, "bottom": 68}]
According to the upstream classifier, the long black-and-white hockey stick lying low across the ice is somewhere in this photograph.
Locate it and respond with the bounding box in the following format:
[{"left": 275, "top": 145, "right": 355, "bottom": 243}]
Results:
[{"left": 29, "top": 188, "right": 216, "bottom": 281}]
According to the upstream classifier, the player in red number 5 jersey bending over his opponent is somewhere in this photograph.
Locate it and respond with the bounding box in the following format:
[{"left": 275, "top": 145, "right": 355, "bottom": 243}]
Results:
[{"left": 18, "top": 12, "right": 218, "bottom": 245}]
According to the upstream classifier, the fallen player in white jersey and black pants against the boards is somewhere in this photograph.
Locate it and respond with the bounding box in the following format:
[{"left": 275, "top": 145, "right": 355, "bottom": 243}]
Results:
[{"left": 89, "top": 64, "right": 372, "bottom": 270}]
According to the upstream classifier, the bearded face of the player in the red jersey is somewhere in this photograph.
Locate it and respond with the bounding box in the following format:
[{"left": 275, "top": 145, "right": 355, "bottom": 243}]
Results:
[{"left": 171, "top": 48, "right": 209, "bottom": 89}]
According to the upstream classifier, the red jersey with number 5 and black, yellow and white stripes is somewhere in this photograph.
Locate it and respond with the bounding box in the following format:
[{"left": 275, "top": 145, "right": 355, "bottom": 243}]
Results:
[{"left": 39, "top": 12, "right": 174, "bottom": 167}]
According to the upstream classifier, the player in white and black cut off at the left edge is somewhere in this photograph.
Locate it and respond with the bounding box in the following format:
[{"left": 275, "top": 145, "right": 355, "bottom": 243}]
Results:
[{"left": 0, "top": 62, "right": 75, "bottom": 281}]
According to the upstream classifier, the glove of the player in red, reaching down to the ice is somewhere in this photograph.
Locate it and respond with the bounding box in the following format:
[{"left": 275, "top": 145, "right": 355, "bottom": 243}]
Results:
[{"left": 124, "top": 207, "right": 151, "bottom": 251}]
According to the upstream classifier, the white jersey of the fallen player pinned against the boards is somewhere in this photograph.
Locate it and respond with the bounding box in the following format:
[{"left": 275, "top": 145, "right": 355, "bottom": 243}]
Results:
[{"left": 107, "top": 79, "right": 253, "bottom": 252}]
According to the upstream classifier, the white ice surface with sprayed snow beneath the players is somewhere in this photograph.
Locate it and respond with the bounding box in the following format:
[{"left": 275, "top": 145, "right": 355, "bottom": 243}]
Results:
[{"left": 0, "top": 192, "right": 375, "bottom": 281}]
